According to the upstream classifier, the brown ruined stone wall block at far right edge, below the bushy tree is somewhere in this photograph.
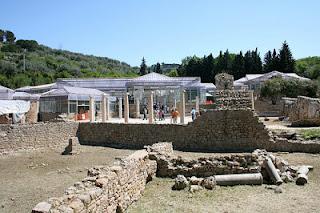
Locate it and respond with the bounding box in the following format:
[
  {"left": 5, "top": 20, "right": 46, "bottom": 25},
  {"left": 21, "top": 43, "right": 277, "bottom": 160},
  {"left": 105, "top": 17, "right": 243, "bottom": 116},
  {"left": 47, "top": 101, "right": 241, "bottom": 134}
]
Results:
[{"left": 283, "top": 96, "right": 320, "bottom": 126}]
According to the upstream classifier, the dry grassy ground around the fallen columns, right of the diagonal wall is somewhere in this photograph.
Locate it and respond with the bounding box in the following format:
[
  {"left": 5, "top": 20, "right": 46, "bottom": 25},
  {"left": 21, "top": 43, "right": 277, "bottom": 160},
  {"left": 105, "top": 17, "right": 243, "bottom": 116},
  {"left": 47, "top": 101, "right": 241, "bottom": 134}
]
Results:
[{"left": 128, "top": 152, "right": 320, "bottom": 213}]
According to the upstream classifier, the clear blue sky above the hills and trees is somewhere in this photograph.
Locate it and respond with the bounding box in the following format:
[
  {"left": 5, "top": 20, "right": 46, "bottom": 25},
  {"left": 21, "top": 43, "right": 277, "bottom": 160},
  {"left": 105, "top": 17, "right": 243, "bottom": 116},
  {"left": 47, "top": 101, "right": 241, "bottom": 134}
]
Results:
[{"left": 0, "top": 0, "right": 320, "bottom": 66}]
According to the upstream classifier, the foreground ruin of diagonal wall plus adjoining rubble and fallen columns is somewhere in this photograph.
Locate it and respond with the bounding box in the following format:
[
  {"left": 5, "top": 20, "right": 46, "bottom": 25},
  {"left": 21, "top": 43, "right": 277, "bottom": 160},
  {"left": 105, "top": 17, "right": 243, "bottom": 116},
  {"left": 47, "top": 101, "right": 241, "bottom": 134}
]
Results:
[{"left": 32, "top": 143, "right": 312, "bottom": 213}]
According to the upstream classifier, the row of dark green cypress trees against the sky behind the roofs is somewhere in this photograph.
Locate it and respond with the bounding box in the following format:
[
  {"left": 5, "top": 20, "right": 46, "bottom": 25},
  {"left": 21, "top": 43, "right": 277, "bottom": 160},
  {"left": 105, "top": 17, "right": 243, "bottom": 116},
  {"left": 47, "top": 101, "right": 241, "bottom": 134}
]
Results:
[{"left": 140, "top": 41, "right": 295, "bottom": 82}]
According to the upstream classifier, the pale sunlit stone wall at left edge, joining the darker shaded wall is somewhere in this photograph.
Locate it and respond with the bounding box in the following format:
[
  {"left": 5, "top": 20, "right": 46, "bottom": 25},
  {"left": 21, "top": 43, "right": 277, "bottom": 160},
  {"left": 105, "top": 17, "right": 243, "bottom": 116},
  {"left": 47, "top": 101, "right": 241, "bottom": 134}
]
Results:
[{"left": 0, "top": 122, "right": 79, "bottom": 155}]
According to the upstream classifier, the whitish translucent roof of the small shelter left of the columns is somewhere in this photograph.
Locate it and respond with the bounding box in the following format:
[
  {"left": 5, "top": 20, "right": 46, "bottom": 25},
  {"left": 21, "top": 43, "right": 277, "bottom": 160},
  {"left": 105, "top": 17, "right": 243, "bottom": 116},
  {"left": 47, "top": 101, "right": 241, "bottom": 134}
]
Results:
[{"left": 41, "top": 86, "right": 105, "bottom": 101}]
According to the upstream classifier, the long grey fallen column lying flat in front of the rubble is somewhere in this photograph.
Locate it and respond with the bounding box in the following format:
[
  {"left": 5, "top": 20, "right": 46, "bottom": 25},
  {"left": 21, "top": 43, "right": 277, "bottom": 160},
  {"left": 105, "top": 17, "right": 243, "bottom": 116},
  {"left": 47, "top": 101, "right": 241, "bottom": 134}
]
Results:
[{"left": 214, "top": 173, "right": 263, "bottom": 186}]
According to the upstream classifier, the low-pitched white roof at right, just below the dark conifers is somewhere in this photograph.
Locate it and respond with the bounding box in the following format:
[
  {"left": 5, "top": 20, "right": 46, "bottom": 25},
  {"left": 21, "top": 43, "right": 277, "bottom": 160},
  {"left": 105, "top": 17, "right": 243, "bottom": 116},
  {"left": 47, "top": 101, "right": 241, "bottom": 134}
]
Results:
[{"left": 234, "top": 70, "right": 310, "bottom": 86}]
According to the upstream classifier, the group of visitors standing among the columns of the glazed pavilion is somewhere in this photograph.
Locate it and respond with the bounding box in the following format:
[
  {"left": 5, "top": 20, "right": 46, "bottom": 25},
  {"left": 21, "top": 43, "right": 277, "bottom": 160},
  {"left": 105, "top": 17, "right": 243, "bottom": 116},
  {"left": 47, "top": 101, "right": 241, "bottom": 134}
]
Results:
[{"left": 142, "top": 103, "right": 197, "bottom": 124}]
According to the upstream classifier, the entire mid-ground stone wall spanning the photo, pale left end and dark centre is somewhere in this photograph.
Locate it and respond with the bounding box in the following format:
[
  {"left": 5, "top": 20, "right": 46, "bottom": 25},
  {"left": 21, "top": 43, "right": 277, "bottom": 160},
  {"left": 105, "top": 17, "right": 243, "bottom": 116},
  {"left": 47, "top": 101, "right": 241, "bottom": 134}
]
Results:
[{"left": 0, "top": 110, "right": 320, "bottom": 154}]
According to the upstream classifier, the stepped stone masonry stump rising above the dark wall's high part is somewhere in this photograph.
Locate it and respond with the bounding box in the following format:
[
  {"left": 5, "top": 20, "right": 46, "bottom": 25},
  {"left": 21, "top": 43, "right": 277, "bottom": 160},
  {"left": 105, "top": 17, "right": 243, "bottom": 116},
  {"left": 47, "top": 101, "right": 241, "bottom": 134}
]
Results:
[{"left": 214, "top": 73, "right": 254, "bottom": 109}]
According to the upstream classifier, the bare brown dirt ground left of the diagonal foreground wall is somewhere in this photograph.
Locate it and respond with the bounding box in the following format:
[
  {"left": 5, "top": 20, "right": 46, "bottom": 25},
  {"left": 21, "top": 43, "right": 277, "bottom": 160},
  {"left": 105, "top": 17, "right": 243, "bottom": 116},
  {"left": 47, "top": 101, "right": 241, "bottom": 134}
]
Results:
[{"left": 0, "top": 146, "right": 133, "bottom": 213}]
